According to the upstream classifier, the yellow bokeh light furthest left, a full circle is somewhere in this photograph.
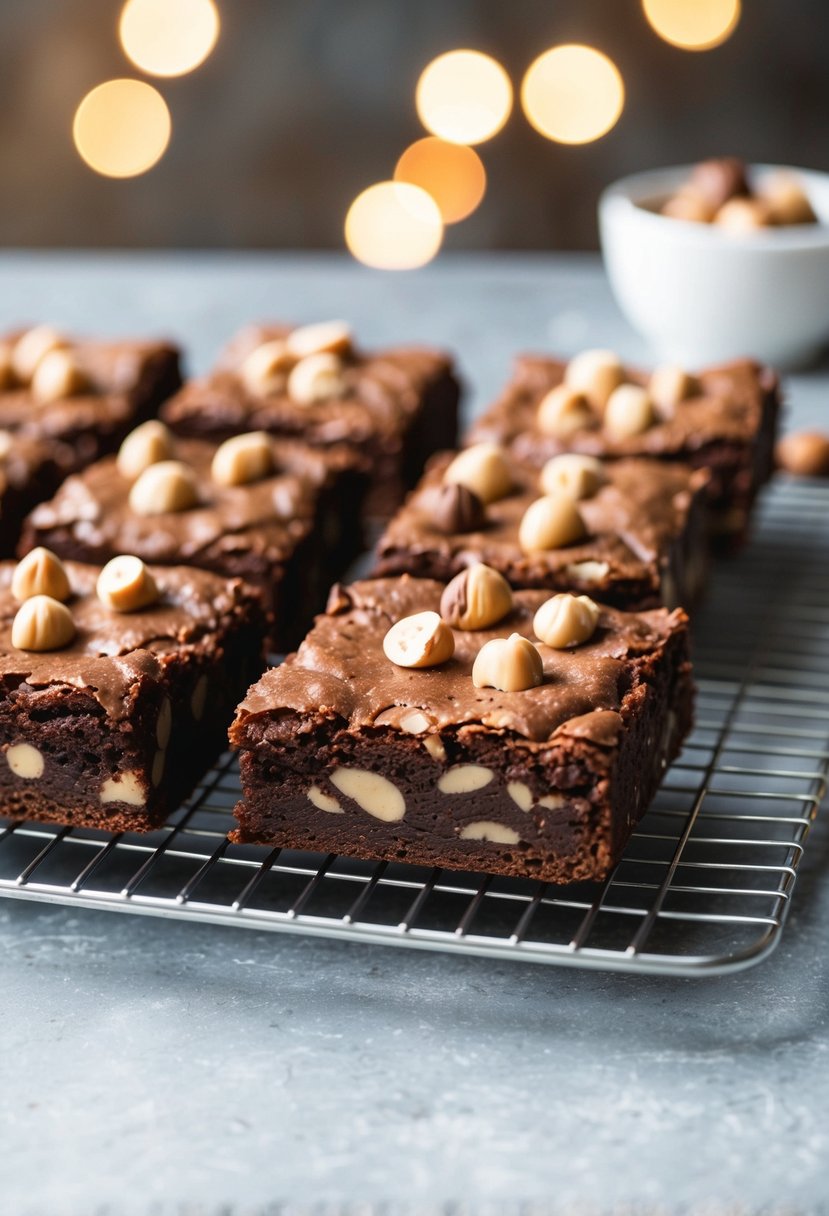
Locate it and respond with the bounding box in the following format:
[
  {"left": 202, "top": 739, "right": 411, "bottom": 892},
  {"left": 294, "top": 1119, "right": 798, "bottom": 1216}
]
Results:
[{"left": 72, "top": 79, "right": 171, "bottom": 178}]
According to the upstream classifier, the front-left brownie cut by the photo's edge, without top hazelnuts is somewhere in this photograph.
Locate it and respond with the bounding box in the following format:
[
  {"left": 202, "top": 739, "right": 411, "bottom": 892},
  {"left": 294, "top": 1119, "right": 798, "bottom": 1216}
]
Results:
[{"left": 0, "top": 562, "right": 263, "bottom": 832}]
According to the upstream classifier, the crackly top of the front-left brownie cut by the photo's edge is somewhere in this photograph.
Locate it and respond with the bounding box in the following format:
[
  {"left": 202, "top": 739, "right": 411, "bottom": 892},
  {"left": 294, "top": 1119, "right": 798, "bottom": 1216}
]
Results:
[{"left": 0, "top": 562, "right": 250, "bottom": 719}]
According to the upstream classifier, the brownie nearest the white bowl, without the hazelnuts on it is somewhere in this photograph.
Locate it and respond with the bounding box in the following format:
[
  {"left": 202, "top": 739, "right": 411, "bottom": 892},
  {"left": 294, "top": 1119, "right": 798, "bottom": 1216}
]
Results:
[{"left": 467, "top": 355, "right": 780, "bottom": 548}]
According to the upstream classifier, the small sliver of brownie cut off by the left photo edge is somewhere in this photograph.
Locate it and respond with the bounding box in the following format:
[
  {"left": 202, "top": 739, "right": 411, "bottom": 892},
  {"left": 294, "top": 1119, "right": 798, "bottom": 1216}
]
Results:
[{"left": 0, "top": 430, "right": 69, "bottom": 558}]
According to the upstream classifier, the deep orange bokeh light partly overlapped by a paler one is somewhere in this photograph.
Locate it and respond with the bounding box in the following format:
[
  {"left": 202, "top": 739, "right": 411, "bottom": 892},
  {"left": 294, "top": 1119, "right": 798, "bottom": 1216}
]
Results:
[{"left": 394, "top": 135, "right": 486, "bottom": 224}]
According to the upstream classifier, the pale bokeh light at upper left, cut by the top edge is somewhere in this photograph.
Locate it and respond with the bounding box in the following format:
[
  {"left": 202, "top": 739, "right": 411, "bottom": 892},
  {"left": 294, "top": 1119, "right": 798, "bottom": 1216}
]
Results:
[{"left": 118, "top": 0, "right": 219, "bottom": 77}]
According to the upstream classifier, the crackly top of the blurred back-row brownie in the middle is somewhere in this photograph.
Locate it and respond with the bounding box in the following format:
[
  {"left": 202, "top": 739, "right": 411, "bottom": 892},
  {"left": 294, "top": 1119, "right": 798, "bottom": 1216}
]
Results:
[{"left": 162, "top": 325, "right": 452, "bottom": 445}]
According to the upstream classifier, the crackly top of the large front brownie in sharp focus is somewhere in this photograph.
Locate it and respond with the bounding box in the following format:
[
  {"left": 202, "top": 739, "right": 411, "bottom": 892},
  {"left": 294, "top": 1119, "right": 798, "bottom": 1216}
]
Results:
[{"left": 233, "top": 575, "right": 687, "bottom": 747}]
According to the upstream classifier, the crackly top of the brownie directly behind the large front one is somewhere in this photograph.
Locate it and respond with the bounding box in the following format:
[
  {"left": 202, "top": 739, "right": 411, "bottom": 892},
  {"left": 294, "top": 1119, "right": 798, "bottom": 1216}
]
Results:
[{"left": 378, "top": 452, "right": 707, "bottom": 585}]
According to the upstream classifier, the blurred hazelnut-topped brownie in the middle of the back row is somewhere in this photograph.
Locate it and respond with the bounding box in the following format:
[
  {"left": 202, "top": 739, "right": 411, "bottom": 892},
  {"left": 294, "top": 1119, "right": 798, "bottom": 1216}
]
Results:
[{"left": 162, "top": 322, "right": 459, "bottom": 519}]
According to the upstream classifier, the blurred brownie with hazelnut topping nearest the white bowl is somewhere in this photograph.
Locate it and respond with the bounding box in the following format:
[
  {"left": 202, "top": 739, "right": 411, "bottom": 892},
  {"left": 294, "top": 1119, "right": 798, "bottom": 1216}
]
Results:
[{"left": 466, "top": 351, "right": 780, "bottom": 548}]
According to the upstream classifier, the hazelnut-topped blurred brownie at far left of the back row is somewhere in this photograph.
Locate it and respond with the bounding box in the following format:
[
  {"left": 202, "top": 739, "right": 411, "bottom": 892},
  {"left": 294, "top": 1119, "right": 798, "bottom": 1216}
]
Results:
[{"left": 0, "top": 325, "right": 181, "bottom": 475}]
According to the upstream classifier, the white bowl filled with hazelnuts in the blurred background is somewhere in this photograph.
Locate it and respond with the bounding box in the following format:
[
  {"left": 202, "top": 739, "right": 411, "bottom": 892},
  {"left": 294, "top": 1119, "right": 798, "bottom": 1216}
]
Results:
[{"left": 599, "top": 157, "right": 829, "bottom": 367}]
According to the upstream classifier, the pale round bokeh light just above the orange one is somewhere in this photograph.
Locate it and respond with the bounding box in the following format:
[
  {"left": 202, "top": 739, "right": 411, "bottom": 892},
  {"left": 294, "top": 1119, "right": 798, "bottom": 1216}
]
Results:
[{"left": 415, "top": 51, "right": 513, "bottom": 143}]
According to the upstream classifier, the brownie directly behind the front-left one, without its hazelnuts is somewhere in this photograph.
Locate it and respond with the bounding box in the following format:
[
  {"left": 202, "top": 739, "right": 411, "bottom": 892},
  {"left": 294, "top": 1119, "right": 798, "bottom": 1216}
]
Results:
[{"left": 19, "top": 439, "right": 365, "bottom": 653}]
